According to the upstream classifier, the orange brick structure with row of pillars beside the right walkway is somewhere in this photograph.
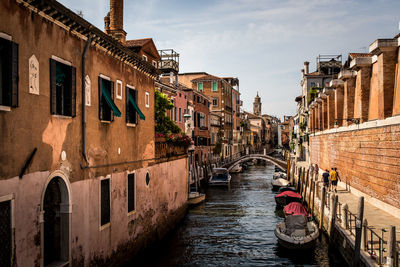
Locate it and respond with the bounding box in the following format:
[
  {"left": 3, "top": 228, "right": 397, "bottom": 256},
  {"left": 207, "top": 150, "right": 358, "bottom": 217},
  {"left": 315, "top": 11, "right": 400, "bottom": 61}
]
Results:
[{"left": 309, "top": 36, "right": 400, "bottom": 216}]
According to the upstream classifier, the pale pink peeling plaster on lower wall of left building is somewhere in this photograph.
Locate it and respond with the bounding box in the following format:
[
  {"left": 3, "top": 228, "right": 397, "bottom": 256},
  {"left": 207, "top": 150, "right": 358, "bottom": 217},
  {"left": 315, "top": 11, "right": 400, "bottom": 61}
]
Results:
[{"left": 0, "top": 158, "right": 188, "bottom": 266}]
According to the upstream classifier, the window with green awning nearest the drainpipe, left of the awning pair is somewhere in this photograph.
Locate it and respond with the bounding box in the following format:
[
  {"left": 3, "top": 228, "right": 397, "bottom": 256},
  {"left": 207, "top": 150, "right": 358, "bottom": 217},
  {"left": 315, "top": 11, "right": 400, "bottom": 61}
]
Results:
[{"left": 99, "top": 75, "right": 121, "bottom": 121}]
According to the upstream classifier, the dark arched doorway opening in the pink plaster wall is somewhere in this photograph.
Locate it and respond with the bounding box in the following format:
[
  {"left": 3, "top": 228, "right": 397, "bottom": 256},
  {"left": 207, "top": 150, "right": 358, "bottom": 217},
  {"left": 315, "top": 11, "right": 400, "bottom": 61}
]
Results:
[{"left": 42, "top": 176, "right": 70, "bottom": 266}]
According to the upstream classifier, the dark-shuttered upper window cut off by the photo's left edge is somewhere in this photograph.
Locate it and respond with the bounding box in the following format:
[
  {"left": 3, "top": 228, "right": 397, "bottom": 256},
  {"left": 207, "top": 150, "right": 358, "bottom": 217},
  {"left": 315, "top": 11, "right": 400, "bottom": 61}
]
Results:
[{"left": 0, "top": 35, "right": 18, "bottom": 107}]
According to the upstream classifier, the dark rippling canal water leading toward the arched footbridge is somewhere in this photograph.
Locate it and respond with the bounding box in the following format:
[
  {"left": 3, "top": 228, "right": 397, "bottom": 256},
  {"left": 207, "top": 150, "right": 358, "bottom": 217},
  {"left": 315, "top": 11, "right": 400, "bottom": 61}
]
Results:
[{"left": 126, "top": 165, "right": 346, "bottom": 266}]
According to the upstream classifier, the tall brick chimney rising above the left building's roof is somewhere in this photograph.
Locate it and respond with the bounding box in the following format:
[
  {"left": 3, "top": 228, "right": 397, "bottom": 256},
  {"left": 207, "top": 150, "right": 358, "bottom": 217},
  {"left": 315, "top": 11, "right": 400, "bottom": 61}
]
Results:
[{"left": 104, "top": 0, "right": 126, "bottom": 44}]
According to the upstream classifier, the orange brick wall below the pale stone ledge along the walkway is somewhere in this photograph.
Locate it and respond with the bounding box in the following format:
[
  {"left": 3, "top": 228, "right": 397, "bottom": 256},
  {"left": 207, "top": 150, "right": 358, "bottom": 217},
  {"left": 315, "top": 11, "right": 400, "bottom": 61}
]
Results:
[{"left": 310, "top": 124, "right": 400, "bottom": 208}]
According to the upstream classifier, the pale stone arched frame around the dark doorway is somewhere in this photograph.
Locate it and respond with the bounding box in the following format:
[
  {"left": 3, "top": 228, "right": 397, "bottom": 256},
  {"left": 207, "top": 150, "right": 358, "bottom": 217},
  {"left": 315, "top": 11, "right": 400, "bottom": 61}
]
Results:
[{"left": 39, "top": 170, "right": 72, "bottom": 267}]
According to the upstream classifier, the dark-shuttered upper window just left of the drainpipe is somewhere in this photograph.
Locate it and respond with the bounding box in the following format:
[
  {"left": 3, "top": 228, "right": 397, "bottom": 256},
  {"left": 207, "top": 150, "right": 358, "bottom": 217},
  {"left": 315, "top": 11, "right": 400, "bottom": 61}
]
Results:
[{"left": 50, "top": 56, "right": 76, "bottom": 117}]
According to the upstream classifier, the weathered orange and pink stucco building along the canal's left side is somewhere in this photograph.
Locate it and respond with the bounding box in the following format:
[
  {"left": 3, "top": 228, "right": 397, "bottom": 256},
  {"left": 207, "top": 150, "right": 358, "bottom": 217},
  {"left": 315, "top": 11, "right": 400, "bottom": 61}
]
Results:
[{"left": 0, "top": 0, "right": 188, "bottom": 266}]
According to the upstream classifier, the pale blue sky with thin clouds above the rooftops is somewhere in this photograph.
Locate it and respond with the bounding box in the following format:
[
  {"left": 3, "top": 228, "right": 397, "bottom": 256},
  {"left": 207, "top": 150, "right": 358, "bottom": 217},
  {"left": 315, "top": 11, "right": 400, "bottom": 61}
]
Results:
[{"left": 59, "top": 0, "right": 400, "bottom": 118}]
